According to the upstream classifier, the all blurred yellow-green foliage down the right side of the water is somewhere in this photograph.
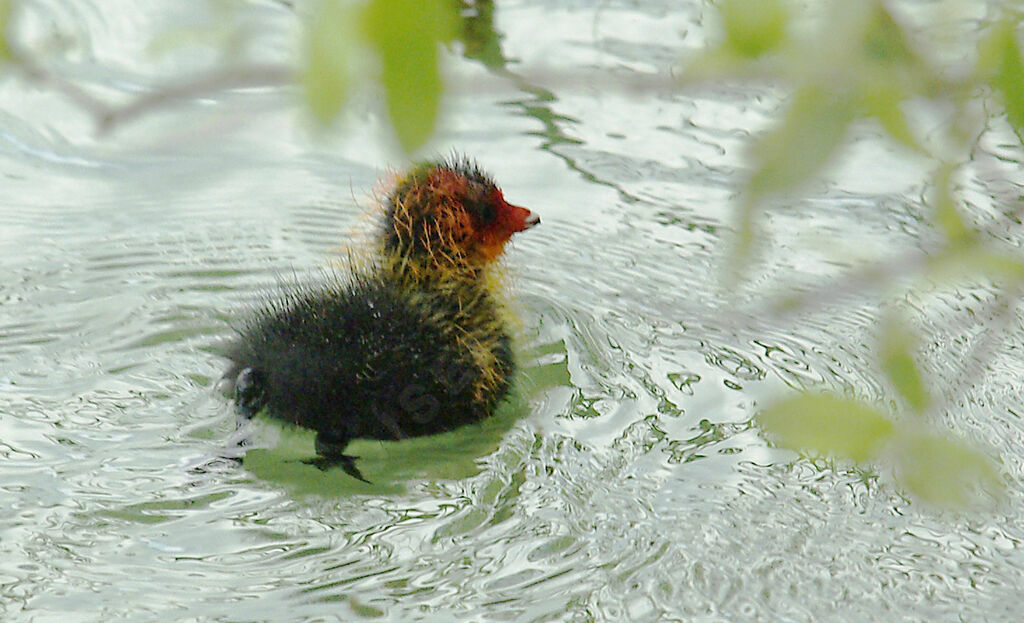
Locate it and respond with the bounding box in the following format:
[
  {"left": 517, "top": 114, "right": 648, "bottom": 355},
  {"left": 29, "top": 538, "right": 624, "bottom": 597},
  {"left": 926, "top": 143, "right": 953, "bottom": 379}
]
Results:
[{"left": 684, "top": 0, "right": 1024, "bottom": 508}]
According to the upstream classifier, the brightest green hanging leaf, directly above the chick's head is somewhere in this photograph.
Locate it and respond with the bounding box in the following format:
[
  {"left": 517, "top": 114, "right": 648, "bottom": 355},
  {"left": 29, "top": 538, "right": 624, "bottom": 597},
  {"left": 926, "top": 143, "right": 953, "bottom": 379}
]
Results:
[{"left": 364, "top": 0, "right": 458, "bottom": 153}]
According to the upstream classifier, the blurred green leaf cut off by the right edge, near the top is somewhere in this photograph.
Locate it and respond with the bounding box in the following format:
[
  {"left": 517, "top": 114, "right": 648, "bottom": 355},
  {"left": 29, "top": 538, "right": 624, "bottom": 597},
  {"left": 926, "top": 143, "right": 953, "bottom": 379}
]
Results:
[{"left": 978, "top": 19, "right": 1024, "bottom": 139}]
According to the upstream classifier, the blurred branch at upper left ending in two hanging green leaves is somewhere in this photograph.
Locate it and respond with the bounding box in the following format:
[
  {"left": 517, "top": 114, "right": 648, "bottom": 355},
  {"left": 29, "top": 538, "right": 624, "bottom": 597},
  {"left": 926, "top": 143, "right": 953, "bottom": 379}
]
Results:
[{"left": 0, "top": 0, "right": 459, "bottom": 153}]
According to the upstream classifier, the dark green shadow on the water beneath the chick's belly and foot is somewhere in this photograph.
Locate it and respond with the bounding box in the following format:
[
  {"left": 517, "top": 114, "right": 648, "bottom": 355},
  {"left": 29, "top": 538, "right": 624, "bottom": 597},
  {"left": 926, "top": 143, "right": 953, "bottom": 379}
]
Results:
[{"left": 242, "top": 394, "right": 527, "bottom": 497}]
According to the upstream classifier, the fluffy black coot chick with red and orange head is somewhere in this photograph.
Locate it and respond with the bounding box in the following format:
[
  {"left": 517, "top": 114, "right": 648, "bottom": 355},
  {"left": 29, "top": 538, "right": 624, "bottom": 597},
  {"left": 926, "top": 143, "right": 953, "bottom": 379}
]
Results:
[{"left": 226, "top": 157, "right": 540, "bottom": 480}]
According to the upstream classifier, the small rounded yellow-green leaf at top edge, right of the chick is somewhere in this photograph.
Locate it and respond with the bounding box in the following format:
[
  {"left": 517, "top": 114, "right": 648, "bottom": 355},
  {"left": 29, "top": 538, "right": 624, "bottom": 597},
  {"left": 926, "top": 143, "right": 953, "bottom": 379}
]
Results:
[{"left": 720, "top": 0, "right": 790, "bottom": 58}]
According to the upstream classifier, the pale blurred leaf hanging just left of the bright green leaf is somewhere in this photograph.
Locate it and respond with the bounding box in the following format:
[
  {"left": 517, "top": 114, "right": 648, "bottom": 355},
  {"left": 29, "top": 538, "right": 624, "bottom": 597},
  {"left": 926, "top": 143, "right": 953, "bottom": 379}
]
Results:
[{"left": 302, "top": 0, "right": 356, "bottom": 125}]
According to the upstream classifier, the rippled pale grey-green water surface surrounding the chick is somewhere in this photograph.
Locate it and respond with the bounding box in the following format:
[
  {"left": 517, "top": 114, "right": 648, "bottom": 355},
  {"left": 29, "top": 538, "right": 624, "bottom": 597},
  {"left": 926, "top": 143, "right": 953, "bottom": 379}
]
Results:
[{"left": 6, "top": 0, "right": 1024, "bottom": 623}]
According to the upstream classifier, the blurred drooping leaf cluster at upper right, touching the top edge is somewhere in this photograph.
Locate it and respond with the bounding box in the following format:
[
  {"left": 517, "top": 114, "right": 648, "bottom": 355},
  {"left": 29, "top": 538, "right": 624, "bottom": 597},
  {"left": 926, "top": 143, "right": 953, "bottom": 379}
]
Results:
[{"left": 696, "top": 0, "right": 939, "bottom": 225}]
